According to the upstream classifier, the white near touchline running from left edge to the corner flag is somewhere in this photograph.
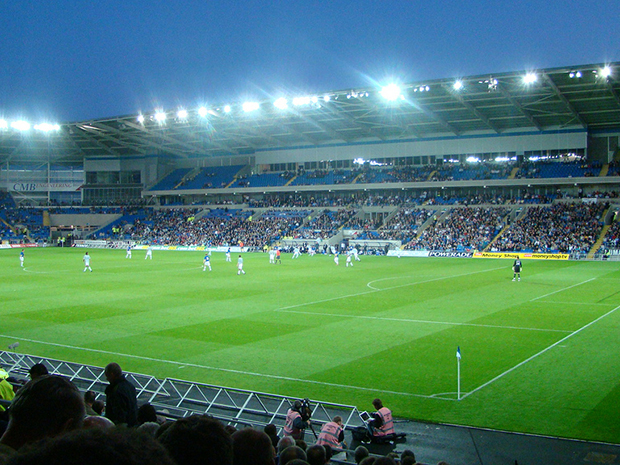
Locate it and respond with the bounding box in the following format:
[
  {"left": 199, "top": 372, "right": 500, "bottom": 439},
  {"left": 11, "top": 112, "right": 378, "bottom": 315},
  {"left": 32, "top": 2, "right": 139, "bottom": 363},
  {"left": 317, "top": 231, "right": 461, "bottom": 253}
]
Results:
[{"left": 0, "top": 334, "right": 456, "bottom": 401}]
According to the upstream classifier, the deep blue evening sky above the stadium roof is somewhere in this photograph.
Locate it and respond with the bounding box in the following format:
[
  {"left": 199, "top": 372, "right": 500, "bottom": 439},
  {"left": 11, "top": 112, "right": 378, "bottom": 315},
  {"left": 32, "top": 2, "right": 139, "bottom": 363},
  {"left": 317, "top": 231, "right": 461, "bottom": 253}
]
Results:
[{"left": 0, "top": 0, "right": 620, "bottom": 122}]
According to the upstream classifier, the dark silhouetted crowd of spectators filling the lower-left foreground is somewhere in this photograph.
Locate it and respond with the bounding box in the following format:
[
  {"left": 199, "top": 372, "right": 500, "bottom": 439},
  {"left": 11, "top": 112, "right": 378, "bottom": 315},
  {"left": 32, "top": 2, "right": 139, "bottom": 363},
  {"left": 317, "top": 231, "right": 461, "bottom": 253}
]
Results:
[{"left": 0, "top": 363, "right": 446, "bottom": 465}]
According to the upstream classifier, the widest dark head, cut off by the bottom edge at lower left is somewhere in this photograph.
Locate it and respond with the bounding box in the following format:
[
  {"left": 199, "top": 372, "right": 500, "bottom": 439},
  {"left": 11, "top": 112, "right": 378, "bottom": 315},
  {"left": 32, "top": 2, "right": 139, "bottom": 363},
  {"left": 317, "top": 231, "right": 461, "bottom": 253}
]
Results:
[{"left": 8, "top": 426, "right": 176, "bottom": 465}]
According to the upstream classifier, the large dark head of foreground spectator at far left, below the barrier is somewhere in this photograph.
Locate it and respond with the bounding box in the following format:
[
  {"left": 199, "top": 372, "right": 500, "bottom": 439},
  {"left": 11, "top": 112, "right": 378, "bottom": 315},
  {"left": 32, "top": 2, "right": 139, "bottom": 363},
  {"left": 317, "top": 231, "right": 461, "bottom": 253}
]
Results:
[{"left": 0, "top": 375, "right": 85, "bottom": 458}]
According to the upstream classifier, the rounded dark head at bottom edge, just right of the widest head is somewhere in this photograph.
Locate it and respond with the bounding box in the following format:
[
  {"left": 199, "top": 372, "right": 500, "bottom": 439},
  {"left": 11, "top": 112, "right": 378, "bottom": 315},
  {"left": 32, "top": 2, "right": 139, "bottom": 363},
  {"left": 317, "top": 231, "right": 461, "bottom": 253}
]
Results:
[{"left": 158, "top": 415, "right": 233, "bottom": 465}]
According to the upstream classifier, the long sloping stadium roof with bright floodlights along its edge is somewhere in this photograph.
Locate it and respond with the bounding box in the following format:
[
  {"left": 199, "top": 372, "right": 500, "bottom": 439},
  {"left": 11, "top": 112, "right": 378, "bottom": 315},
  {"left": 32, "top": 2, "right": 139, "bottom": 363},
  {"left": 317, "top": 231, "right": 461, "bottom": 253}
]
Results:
[{"left": 0, "top": 63, "right": 620, "bottom": 163}]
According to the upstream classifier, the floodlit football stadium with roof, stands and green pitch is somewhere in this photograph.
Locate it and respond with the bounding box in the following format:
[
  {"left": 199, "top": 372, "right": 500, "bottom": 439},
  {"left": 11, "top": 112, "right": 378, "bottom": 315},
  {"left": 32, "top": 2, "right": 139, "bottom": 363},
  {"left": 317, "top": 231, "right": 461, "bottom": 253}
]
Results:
[{"left": 0, "top": 63, "right": 620, "bottom": 464}]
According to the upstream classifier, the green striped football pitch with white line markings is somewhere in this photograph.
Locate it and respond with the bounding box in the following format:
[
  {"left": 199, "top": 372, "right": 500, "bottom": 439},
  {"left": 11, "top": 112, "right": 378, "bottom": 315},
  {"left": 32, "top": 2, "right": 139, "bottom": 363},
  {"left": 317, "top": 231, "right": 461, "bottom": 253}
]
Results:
[{"left": 0, "top": 248, "right": 620, "bottom": 443}]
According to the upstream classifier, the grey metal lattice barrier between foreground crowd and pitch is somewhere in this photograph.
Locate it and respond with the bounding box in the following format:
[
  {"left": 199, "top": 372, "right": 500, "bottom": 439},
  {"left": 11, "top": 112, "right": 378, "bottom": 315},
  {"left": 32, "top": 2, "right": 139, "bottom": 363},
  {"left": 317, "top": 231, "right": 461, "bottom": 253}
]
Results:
[{"left": 0, "top": 350, "right": 364, "bottom": 435}]
